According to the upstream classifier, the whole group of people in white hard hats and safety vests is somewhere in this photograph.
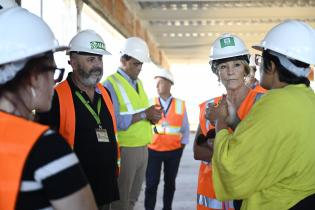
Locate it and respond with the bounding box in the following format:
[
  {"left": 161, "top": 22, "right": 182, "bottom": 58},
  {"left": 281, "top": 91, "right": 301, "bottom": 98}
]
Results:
[{"left": 0, "top": 0, "right": 315, "bottom": 210}]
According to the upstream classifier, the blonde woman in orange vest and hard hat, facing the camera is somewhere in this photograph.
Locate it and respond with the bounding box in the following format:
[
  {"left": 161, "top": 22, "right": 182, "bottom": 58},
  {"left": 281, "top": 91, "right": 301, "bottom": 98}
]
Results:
[{"left": 194, "top": 34, "right": 263, "bottom": 210}]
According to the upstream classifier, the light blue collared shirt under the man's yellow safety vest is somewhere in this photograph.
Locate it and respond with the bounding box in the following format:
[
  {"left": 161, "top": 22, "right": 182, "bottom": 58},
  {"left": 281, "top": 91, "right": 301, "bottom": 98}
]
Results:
[{"left": 104, "top": 68, "right": 137, "bottom": 131}]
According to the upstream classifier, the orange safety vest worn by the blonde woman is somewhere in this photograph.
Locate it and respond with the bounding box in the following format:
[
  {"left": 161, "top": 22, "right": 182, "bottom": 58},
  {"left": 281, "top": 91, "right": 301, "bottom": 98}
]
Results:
[{"left": 197, "top": 89, "right": 265, "bottom": 210}]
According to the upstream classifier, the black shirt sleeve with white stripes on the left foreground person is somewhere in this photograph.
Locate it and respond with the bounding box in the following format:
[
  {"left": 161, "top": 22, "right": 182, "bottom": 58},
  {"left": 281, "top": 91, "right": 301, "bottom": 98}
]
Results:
[{"left": 16, "top": 130, "right": 88, "bottom": 210}]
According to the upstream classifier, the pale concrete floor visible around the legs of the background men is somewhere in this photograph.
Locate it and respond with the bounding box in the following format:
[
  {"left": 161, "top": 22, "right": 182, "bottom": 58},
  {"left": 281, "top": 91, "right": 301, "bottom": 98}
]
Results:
[{"left": 135, "top": 133, "right": 199, "bottom": 210}]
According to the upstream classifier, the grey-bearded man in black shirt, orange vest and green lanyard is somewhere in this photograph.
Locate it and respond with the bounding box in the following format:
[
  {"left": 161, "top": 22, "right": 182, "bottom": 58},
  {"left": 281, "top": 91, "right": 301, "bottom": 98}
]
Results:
[{"left": 38, "top": 30, "right": 119, "bottom": 210}]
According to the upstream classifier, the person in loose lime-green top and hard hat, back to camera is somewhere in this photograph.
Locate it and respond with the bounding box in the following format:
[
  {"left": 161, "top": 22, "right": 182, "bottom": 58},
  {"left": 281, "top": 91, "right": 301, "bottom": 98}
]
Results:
[{"left": 212, "top": 20, "right": 315, "bottom": 210}]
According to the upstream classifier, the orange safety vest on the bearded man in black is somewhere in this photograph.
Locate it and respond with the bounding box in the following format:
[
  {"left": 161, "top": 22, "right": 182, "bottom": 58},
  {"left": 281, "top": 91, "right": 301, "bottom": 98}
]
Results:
[{"left": 55, "top": 80, "right": 120, "bottom": 171}]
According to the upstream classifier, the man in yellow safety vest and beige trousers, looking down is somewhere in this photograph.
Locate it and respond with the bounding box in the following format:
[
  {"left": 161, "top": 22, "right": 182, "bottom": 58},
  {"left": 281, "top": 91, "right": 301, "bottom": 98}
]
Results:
[{"left": 104, "top": 37, "right": 162, "bottom": 210}]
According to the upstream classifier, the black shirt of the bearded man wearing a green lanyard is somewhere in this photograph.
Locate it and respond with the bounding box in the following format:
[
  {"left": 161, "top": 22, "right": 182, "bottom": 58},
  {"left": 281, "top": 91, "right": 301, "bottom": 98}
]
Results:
[{"left": 37, "top": 74, "right": 119, "bottom": 205}]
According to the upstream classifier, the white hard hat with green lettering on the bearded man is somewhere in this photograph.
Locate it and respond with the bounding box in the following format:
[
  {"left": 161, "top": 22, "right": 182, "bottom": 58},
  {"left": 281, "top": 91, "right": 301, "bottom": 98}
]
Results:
[{"left": 67, "top": 30, "right": 111, "bottom": 55}]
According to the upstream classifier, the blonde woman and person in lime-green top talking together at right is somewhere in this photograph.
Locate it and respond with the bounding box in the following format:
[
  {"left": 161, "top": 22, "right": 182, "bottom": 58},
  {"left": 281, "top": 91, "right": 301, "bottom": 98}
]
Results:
[{"left": 194, "top": 17, "right": 315, "bottom": 210}]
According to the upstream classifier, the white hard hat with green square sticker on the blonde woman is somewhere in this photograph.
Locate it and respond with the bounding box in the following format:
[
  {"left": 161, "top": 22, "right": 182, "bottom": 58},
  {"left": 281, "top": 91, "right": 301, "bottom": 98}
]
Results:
[{"left": 209, "top": 33, "right": 249, "bottom": 64}]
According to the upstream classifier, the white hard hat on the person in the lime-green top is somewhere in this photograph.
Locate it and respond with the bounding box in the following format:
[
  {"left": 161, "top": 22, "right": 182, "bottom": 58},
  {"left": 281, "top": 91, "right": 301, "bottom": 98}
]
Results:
[{"left": 253, "top": 20, "right": 315, "bottom": 64}]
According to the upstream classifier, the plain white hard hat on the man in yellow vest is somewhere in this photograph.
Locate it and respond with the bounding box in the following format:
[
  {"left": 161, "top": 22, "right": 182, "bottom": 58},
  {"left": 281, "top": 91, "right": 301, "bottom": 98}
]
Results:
[{"left": 120, "top": 37, "right": 151, "bottom": 63}]
